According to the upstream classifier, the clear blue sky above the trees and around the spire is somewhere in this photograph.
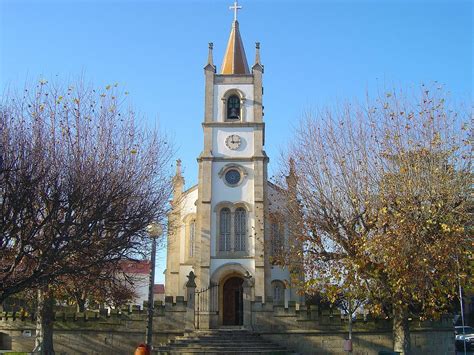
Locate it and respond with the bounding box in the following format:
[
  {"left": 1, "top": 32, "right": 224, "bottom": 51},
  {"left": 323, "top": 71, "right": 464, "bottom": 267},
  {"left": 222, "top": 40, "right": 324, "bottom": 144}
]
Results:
[{"left": 0, "top": 0, "right": 474, "bottom": 282}]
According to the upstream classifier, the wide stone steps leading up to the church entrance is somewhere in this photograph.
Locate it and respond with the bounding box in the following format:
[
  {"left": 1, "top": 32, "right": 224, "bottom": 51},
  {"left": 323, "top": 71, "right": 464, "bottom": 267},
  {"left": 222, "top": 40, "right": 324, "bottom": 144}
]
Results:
[{"left": 153, "top": 329, "right": 294, "bottom": 355}]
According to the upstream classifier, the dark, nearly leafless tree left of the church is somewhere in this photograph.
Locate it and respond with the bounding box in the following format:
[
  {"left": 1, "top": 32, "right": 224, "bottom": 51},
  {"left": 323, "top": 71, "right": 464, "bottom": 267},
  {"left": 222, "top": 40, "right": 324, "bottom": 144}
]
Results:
[{"left": 0, "top": 80, "right": 172, "bottom": 353}]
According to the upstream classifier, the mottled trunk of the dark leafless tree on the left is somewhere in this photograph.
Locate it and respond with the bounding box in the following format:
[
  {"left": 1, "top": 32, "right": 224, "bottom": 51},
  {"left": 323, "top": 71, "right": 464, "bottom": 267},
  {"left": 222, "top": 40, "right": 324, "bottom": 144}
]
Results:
[{"left": 34, "top": 286, "right": 54, "bottom": 355}]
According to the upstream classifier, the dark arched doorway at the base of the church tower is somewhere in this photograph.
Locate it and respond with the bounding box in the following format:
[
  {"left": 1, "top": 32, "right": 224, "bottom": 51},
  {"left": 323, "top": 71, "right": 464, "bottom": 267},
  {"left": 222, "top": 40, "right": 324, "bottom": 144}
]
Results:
[{"left": 222, "top": 276, "right": 244, "bottom": 325}]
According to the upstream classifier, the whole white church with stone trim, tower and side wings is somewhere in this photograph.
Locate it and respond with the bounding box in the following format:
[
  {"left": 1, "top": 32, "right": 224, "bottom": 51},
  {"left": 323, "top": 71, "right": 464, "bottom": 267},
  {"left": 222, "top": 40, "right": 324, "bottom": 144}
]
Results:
[{"left": 165, "top": 3, "right": 300, "bottom": 328}]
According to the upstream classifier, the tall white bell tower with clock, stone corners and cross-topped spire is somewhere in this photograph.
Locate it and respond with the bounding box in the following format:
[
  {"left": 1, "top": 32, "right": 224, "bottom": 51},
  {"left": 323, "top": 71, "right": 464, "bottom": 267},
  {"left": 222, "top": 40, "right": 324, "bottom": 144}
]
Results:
[{"left": 194, "top": 3, "right": 270, "bottom": 304}]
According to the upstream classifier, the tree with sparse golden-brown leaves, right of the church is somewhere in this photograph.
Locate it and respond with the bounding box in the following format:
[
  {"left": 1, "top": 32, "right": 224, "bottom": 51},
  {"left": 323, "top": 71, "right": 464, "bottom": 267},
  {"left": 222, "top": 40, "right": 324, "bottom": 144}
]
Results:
[{"left": 285, "top": 86, "right": 472, "bottom": 354}]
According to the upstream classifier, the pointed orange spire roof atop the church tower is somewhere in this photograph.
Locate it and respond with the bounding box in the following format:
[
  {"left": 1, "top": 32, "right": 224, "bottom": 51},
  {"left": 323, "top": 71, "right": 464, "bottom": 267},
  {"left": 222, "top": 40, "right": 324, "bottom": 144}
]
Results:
[{"left": 221, "top": 21, "right": 250, "bottom": 74}]
